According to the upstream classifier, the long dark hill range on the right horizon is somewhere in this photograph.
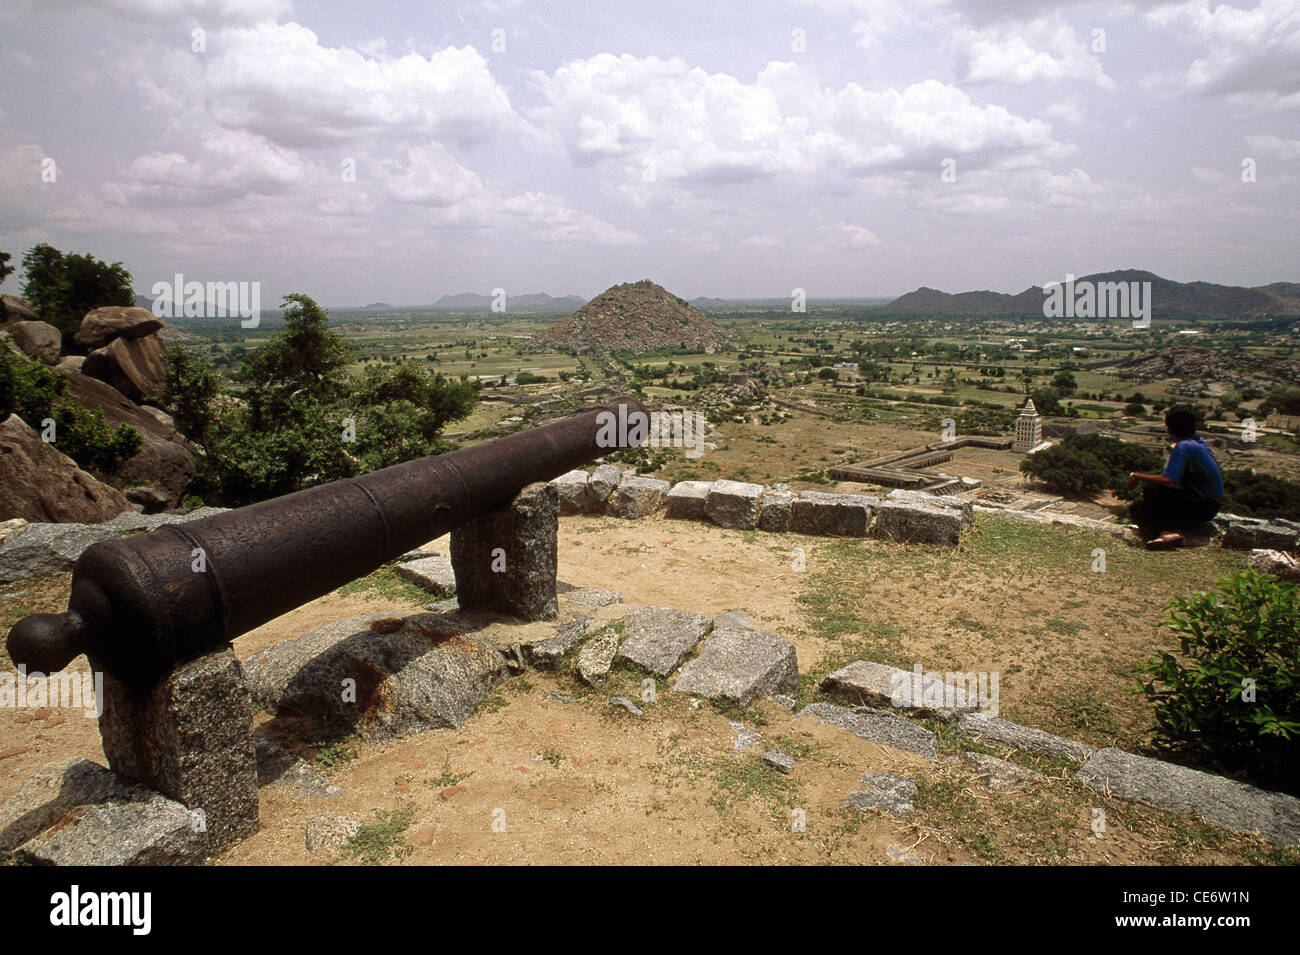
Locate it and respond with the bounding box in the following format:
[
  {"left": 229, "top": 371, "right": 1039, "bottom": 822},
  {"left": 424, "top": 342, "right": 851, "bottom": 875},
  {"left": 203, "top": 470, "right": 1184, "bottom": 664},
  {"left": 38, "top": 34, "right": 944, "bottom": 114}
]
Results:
[{"left": 883, "top": 269, "right": 1300, "bottom": 318}]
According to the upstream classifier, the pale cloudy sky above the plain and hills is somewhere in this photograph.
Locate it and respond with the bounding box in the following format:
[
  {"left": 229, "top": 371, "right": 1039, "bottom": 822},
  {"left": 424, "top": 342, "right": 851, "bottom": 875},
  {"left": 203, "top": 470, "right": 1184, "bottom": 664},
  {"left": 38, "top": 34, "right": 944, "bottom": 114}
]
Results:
[{"left": 0, "top": 0, "right": 1300, "bottom": 305}]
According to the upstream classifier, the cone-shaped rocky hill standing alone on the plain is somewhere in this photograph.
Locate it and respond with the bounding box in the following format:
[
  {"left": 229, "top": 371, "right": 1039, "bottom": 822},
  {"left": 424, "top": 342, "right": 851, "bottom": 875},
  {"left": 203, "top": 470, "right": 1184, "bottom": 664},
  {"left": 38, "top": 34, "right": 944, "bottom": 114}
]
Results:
[{"left": 533, "top": 278, "right": 727, "bottom": 352}]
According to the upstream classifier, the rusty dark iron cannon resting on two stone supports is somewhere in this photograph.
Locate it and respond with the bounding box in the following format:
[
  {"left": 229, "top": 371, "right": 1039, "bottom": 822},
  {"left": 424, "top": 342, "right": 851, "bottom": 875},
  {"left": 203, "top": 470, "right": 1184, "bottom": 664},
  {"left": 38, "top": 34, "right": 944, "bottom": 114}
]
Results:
[{"left": 7, "top": 399, "right": 646, "bottom": 687}]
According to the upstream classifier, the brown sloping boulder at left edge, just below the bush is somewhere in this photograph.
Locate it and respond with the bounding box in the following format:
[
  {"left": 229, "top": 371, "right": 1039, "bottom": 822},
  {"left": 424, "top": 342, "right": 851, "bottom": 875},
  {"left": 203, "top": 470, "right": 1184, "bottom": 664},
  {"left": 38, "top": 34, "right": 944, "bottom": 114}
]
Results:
[{"left": 0, "top": 414, "right": 131, "bottom": 524}]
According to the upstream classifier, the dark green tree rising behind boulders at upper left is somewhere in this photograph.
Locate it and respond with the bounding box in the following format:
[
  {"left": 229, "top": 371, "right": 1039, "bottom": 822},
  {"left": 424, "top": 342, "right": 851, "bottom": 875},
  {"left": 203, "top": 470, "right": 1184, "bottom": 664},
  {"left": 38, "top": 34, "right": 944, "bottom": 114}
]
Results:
[{"left": 22, "top": 243, "right": 135, "bottom": 338}]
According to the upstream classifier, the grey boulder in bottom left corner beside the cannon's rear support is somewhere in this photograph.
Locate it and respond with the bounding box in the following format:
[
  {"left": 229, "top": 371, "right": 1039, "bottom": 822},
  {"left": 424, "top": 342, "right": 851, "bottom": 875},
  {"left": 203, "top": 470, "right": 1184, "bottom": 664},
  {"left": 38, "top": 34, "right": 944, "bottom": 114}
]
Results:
[{"left": 0, "top": 756, "right": 205, "bottom": 867}]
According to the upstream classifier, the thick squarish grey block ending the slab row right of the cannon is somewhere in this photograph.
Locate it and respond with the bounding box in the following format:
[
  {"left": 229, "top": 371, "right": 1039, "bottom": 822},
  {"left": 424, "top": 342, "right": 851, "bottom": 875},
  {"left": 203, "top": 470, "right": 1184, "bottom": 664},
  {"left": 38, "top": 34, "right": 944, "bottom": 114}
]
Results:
[{"left": 673, "top": 630, "right": 800, "bottom": 707}]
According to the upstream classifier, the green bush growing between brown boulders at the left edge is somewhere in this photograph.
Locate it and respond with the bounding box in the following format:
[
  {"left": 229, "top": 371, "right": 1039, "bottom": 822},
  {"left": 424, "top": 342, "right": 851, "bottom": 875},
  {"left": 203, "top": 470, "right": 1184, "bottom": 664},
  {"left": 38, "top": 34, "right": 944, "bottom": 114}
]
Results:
[{"left": 0, "top": 350, "right": 143, "bottom": 477}]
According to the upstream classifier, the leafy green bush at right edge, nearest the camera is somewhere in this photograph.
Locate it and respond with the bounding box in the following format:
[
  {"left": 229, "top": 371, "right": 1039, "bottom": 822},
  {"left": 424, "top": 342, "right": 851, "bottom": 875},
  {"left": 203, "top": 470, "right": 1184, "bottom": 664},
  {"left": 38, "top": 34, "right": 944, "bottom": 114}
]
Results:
[{"left": 1134, "top": 570, "right": 1300, "bottom": 791}]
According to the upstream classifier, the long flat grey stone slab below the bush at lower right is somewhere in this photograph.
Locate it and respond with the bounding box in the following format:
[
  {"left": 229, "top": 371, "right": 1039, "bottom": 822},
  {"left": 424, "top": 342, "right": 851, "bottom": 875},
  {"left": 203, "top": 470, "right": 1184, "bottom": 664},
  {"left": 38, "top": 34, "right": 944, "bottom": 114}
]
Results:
[{"left": 1074, "top": 747, "right": 1300, "bottom": 846}]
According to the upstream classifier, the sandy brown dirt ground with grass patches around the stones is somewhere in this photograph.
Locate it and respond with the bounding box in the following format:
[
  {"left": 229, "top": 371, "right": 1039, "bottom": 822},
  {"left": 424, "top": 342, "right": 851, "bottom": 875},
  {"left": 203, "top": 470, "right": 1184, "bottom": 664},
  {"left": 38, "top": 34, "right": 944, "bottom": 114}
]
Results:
[{"left": 0, "top": 517, "right": 1273, "bottom": 865}]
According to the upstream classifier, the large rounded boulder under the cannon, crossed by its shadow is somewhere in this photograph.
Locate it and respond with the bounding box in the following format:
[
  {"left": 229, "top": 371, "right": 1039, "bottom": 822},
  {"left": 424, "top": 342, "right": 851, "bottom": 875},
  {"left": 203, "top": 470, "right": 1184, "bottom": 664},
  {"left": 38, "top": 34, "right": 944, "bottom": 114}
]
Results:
[{"left": 242, "top": 613, "right": 506, "bottom": 742}]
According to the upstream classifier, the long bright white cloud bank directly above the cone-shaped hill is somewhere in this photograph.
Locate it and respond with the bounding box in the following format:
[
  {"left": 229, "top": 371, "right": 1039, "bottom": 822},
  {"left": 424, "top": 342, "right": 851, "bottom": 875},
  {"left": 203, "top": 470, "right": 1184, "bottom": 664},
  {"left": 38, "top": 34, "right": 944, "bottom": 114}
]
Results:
[{"left": 530, "top": 53, "right": 1070, "bottom": 192}]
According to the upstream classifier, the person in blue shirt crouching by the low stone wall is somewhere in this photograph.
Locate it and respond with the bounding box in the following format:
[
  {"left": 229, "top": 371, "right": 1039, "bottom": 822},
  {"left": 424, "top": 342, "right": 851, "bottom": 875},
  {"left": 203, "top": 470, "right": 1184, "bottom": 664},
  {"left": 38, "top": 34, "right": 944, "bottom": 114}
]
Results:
[{"left": 1125, "top": 411, "right": 1223, "bottom": 551}]
